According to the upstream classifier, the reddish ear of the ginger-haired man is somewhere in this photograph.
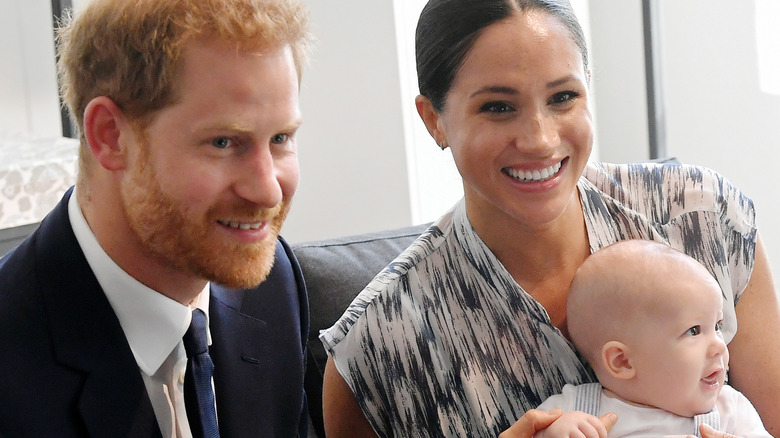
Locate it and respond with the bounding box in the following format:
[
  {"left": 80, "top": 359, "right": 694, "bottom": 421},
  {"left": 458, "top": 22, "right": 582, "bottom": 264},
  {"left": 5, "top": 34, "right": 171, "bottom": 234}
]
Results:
[{"left": 84, "top": 96, "right": 132, "bottom": 171}]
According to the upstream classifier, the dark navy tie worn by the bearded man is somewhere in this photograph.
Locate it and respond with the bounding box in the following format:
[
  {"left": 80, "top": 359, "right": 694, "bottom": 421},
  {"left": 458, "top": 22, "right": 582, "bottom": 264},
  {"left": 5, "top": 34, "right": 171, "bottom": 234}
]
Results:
[{"left": 183, "top": 309, "right": 219, "bottom": 438}]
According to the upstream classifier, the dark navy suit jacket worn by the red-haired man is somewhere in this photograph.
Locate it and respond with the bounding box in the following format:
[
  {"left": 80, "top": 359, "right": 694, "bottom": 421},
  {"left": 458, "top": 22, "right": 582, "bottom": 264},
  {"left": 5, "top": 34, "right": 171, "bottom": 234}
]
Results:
[{"left": 0, "top": 191, "right": 308, "bottom": 438}]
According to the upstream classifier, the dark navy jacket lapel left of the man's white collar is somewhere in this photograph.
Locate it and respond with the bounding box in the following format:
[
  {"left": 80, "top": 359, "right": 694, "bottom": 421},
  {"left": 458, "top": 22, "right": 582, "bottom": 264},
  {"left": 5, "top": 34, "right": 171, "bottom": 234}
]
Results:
[{"left": 35, "top": 191, "right": 160, "bottom": 437}]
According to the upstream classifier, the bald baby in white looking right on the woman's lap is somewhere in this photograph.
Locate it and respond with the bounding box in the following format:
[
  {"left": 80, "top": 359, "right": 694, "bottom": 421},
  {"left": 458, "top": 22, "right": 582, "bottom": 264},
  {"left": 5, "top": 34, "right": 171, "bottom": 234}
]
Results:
[{"left": 536, "top": 240, "right": 771, "bottom": 438}]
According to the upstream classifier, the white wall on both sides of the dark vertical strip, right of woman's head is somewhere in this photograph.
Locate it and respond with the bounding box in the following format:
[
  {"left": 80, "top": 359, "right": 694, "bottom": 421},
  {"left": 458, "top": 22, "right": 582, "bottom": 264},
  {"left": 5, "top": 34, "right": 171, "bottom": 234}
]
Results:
[{"left": 591, "top": 0, "right": 780, "bottom": 281}]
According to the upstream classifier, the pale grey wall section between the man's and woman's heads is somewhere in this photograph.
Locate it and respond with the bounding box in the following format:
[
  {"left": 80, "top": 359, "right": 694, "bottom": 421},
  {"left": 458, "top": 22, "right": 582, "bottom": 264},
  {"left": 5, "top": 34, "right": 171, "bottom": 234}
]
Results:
[{"left": 283, "top": 0, "right": 418, "bottom": 242}]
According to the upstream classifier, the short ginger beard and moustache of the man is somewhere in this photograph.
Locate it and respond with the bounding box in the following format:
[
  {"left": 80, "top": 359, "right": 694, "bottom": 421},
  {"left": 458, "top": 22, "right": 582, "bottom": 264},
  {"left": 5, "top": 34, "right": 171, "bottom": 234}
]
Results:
[{"left": 121, "top": 144, "right": 289, "bottom": 289}]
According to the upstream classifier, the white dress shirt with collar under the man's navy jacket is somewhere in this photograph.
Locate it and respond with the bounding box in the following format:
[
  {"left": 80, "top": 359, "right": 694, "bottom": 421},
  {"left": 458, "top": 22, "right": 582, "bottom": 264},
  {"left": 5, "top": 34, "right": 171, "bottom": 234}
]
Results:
[{"left": 68, "top": 188, "right": 211, "bottom": 438}]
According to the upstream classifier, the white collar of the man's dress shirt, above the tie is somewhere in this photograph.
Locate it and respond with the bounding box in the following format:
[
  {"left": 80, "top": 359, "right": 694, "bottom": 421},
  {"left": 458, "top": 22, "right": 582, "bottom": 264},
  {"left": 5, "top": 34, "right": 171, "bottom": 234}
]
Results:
[{"left": 68, "top": 188, "right": 211, "bottom": 376}]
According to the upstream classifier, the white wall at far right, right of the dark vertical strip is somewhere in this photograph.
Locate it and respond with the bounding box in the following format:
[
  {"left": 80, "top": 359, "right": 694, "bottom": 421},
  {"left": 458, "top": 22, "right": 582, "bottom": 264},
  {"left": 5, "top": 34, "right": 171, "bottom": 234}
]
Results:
[{"left": 661, "top": 0, "right": 780, "bottom": 279}]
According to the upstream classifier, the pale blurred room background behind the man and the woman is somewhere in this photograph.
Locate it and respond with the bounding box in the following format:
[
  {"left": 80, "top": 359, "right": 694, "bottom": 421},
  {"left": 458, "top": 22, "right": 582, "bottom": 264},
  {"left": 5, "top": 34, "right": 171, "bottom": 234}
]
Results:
[{"left": 0, "top": 0, "right": 780, "bottom": 278}]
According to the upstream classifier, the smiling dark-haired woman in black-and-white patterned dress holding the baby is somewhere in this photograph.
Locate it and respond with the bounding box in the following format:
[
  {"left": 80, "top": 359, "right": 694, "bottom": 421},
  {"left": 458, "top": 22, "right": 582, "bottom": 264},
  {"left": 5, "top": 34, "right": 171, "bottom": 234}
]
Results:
[{"left": 321, "top": 0, "right": 780, "bottom": 437}]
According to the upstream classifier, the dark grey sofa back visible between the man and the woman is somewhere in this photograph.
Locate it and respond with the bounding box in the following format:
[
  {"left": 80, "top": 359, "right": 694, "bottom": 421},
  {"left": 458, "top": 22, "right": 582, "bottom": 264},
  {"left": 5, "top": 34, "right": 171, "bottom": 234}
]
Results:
[{"left": 293, "top": 224, "right": 428, "bottom": 438}]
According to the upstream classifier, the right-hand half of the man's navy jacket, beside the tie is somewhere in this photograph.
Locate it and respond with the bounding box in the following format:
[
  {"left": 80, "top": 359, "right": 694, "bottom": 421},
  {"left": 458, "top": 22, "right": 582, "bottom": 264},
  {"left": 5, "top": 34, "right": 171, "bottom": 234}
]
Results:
[{"left": 209, "top": 239, "right": 308, "bottom": 437}]
